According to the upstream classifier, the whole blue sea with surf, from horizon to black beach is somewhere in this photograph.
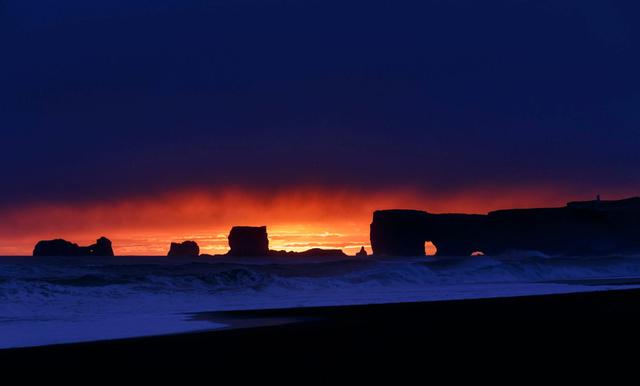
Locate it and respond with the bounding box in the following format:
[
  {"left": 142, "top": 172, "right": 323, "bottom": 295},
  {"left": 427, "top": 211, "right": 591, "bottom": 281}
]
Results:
[{"left": 0, "top": 252, "right": 640, "bottom": 347}]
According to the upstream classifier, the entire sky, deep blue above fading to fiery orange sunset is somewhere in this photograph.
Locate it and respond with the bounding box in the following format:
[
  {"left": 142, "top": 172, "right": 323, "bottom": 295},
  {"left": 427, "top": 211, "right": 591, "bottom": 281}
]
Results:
[{"left": 0, "top": 0, "right": 640, "bottom": 254}]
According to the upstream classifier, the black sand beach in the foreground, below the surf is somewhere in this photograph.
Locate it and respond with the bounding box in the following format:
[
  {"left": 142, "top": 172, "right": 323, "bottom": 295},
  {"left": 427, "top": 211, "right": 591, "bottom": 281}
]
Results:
[{"left": 0, "top": 289, "right": 640, "bottom": 372}]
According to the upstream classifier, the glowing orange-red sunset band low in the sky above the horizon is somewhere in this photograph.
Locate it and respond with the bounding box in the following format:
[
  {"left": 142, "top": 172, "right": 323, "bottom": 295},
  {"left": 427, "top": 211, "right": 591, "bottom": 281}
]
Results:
[{"left": 0, "top": 188, "right": 616, "bottom": 255}]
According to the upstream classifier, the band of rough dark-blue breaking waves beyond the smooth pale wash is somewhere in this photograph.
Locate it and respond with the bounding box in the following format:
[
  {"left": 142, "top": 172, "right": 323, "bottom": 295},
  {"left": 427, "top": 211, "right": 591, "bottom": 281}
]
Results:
[{"left": 0, "top": 255, "right": 640, "bottom": 296}]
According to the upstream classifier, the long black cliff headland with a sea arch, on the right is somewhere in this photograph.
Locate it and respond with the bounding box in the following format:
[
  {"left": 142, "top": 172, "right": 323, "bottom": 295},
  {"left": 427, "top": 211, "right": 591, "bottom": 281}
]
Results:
[{"left": 371, "top": 197, "right": 640, "bottom": 256}]
